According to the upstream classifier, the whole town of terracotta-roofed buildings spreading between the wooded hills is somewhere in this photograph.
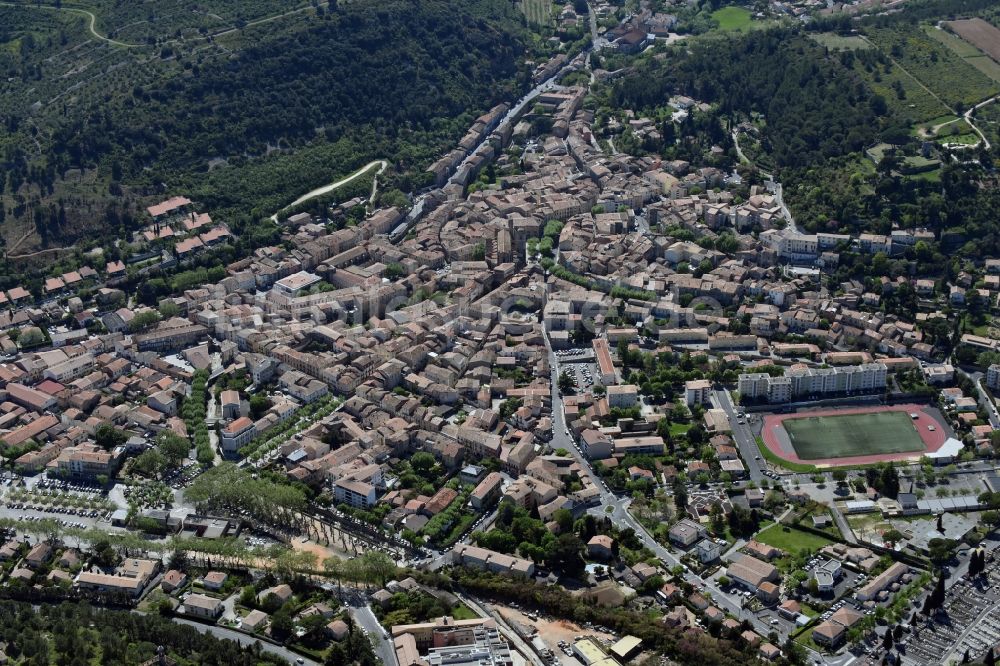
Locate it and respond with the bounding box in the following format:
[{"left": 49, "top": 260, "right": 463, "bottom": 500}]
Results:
[{"left": 0, "top": 3, "right": 1000, "bottom": 666}]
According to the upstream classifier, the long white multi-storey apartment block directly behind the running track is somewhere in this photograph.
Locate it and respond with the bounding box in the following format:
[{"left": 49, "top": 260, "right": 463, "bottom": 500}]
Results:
[{"left": 739, "top": 363, "right": 887, "bottom": 403}]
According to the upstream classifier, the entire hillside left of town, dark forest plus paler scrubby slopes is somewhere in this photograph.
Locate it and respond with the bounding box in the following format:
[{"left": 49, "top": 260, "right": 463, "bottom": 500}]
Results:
[{"left": 0, "top": 0, "right": 530, "bottom": 243}]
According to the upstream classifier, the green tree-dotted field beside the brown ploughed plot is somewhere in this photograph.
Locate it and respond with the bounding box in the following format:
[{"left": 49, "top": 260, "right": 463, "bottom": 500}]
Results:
[{"left": 868, "top": 26, "right": 1000, "bottom": 115}]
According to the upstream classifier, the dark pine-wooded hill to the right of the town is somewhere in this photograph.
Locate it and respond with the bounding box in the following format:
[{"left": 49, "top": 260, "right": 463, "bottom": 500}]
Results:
[{"left": 611, "top": 29, "right": 887, "bottom": 168}]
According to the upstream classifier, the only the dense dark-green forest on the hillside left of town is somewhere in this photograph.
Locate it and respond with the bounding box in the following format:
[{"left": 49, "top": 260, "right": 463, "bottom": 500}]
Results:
[{"left": 81, "top": 0, "right": 521, "bottom": 179}]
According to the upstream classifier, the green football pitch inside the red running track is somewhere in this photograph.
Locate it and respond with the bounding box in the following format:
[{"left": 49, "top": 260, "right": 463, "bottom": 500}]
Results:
[{"left": 781, "top": 412, "right": 924, "bottom": 460}]
